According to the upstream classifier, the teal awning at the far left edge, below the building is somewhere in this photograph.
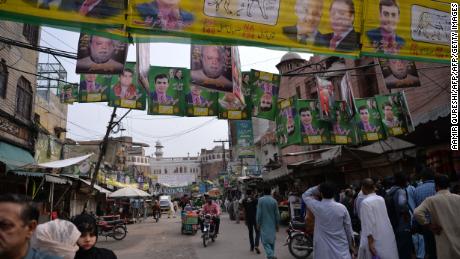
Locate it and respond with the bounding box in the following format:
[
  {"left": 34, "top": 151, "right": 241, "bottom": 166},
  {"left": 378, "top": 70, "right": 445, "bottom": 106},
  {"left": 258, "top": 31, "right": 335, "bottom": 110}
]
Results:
[{"left": 0, "top": 142, "right": 35, "bottom": 171}]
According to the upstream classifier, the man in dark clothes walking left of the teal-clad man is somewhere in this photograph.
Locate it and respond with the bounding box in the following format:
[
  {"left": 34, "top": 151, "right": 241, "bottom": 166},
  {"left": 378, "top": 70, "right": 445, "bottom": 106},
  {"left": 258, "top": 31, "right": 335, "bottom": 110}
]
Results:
[{"left": 243, "top": 190, "right": 260, "bottom": 254}]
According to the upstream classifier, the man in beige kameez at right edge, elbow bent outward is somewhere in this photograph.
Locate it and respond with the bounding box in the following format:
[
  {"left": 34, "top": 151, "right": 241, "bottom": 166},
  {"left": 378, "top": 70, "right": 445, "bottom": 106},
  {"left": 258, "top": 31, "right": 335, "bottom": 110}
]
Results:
[{"left": 414, "top": 175, "right": 460, "bottom": 258}]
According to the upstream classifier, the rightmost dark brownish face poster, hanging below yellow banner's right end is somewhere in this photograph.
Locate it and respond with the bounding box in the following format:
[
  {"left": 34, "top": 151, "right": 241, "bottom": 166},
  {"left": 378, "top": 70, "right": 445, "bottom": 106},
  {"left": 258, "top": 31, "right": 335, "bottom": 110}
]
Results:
[{"left": 379, "top": 58, "right": 420, "bottom": 89}]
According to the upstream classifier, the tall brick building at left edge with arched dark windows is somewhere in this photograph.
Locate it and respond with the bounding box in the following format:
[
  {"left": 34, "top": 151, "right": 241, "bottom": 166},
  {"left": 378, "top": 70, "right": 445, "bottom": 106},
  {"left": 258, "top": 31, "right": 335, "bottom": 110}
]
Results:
[{"left": 0, "top": 21, "right": 40, "bottom": 193}]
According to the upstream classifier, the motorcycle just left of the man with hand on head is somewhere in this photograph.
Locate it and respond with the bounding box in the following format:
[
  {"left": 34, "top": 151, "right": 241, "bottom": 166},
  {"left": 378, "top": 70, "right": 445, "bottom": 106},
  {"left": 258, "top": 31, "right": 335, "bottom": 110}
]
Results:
[{"left": 284, "top": 220, "right": 313, "bottom": 259}]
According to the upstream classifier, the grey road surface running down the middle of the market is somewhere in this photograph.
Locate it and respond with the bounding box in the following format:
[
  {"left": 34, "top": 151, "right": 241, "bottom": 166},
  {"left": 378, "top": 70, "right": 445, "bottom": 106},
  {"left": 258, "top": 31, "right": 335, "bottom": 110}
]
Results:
[{"left": 97, "top": 214, "right": 294, "bottom": 259}]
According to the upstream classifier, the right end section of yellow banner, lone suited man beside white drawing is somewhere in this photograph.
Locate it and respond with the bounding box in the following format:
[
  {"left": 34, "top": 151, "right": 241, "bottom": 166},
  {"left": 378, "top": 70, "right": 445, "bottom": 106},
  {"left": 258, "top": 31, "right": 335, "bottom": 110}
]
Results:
[{"left": 361, "top": 0, "right": 450, "bottom": 61}]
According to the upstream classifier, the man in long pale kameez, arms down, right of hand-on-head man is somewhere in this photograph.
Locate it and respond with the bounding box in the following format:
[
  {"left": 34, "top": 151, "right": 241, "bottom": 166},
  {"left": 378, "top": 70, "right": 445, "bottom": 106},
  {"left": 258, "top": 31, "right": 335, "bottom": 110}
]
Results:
[{"left": 358, "top": 178, "right": 398, "bottom": 259}]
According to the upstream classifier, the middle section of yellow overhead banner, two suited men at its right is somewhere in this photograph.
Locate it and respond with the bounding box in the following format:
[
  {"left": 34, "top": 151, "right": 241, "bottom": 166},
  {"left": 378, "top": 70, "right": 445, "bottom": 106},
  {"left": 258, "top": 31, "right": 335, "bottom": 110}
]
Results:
[{"left": 128, "top": 0, "right": 362, "bottom": 56}]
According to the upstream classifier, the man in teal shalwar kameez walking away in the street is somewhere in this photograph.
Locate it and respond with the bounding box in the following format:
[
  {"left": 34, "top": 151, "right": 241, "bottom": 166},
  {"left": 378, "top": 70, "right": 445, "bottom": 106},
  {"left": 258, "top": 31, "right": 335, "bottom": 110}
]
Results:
[{"left": 256, "top": 188, "right": 280, "bottom": 259}]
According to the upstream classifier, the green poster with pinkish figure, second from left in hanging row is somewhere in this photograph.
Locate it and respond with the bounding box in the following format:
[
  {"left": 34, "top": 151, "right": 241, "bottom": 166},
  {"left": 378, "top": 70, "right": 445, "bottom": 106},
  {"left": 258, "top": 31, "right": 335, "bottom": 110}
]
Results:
[{"left": 109, "top": 62, "right": 146, "bottom": 110}]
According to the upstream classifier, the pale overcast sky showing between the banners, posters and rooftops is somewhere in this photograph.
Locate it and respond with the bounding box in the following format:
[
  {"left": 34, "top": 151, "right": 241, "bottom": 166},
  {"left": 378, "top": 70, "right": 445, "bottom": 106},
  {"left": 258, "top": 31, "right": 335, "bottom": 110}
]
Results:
[{"left": 40, "top": 27, "right": 311, "bottom": 157}]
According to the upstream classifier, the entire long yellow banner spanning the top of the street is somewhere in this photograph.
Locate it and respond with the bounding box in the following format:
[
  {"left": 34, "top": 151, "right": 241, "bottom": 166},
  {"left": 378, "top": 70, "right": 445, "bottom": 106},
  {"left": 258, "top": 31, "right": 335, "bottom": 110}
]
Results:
[{"left": 0, "top": 0, "right": 450, "bottom": 63}]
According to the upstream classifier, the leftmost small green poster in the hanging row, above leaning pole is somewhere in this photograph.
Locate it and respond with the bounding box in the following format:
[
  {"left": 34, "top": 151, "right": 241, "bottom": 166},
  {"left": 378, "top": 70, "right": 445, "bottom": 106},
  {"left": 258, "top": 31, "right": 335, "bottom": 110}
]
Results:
[{"left": 79, "top": 74, "right": 112, "bottom": 103}]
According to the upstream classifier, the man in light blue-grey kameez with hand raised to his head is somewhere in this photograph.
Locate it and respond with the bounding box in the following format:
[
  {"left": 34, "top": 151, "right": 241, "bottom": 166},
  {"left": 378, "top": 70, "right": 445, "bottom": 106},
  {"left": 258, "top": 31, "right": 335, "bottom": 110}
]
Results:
[{"left": 302, "top": 182, "right": 354, "bottom": 259}]
